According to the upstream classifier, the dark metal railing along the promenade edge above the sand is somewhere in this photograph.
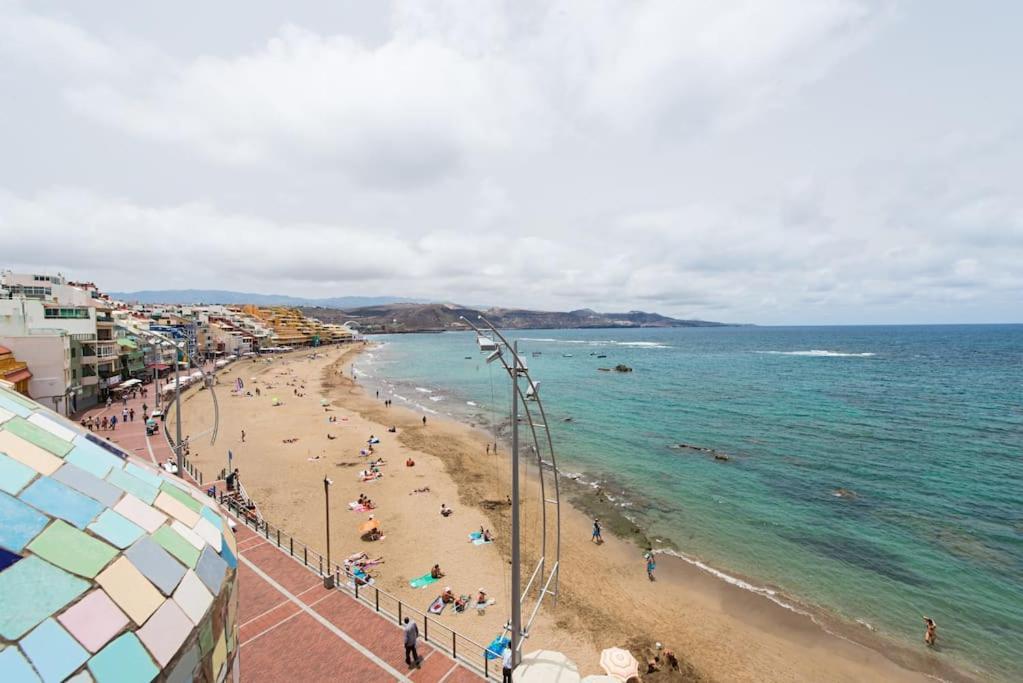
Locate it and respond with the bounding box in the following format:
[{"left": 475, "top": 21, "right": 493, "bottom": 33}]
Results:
[{"left": 219, "top": 492, "right": 501, "bottom": 681}]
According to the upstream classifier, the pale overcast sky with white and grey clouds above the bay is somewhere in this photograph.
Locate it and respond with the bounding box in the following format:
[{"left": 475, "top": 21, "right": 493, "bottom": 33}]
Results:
[{"left": 0, "top": 0, "right": 1023, "bottom": 324}]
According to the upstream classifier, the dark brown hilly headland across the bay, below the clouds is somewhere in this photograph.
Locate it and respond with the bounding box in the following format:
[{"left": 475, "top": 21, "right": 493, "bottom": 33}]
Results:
[{"left": 301, "top": 304, "right": 726, "bottom": 333}]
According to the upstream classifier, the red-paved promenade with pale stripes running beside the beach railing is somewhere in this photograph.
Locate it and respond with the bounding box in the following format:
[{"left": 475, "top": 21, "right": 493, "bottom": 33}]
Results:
[{"left": 76, "top": 384, "right": 486, "bottom": 683}]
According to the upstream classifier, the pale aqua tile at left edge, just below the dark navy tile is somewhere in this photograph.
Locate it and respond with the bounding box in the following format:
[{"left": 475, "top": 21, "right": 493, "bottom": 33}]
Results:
[{"left": 0, "top": 556, "right": 89, "bottom": 640}]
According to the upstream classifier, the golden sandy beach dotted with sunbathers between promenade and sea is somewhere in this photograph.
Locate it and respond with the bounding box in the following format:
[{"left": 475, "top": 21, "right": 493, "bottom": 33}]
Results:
[{"left": 183, "top": 346, "right": 970, "bottom": 681}]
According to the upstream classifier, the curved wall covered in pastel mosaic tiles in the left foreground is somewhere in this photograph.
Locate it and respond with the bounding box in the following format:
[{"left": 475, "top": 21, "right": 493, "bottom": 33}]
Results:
[{"left": 0, "top": 384, "right": 237, "bottom": 683}]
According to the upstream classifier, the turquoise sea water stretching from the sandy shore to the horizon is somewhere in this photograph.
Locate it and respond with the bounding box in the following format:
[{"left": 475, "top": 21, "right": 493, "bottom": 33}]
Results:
[{"left": 357, "top": 325, "right": 1023, "bottom": 680}]
